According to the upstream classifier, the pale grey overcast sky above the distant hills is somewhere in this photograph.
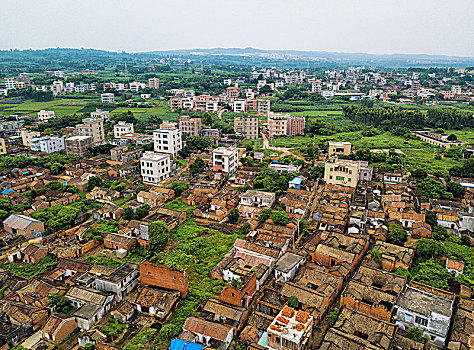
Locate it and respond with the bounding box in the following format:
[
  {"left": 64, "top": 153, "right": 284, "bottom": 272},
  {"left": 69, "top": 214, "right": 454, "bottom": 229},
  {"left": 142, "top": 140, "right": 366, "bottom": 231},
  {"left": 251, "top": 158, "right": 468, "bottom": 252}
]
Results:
[{"left": 0, "top": 0, "right": 474, "bottom": 56}]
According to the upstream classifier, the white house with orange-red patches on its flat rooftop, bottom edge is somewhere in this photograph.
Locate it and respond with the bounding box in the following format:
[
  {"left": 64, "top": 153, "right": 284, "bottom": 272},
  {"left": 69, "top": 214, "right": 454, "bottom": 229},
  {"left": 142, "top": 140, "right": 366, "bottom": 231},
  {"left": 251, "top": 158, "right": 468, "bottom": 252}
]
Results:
[{"left": 266, "top": 306, "right": 314, "bottom": 350}]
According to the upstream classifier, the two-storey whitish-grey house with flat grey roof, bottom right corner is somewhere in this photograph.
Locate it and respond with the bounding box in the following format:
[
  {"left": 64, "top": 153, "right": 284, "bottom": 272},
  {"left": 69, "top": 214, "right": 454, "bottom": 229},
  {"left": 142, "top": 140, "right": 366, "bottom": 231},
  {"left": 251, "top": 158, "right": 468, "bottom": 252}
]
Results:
[{"left": 395, "top": 281, "right": 454, "bottom": 347}]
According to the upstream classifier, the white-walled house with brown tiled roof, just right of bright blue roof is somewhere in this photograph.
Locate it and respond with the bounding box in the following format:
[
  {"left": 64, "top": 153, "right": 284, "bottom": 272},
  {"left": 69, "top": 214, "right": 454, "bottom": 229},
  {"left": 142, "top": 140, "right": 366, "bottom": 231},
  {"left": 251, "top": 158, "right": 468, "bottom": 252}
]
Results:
[{"left": 183, "top": 317, "right": 234, "bottom": 350}]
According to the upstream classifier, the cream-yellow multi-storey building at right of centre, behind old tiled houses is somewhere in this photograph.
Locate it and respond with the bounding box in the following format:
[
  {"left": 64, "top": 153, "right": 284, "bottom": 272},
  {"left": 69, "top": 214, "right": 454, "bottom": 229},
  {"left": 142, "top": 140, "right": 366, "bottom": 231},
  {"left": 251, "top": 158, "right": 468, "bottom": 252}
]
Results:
[{"left": 324, "top": 159, "right": 360, "bottom": 187}]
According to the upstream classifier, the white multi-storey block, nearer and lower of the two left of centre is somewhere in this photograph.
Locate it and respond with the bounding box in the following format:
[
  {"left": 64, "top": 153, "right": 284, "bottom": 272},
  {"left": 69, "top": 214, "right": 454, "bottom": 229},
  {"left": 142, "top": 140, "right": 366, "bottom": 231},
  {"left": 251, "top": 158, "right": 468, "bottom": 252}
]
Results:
[{"left": 140, "top": 152, "right": 171, "bottom": 185}]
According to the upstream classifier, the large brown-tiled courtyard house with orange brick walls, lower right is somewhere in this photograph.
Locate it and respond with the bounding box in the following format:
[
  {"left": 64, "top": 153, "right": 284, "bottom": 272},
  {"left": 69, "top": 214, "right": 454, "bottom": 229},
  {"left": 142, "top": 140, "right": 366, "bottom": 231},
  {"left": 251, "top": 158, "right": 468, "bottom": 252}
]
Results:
[{"left": 340, "top": 266, "right": 406, "bottom": 322}]
